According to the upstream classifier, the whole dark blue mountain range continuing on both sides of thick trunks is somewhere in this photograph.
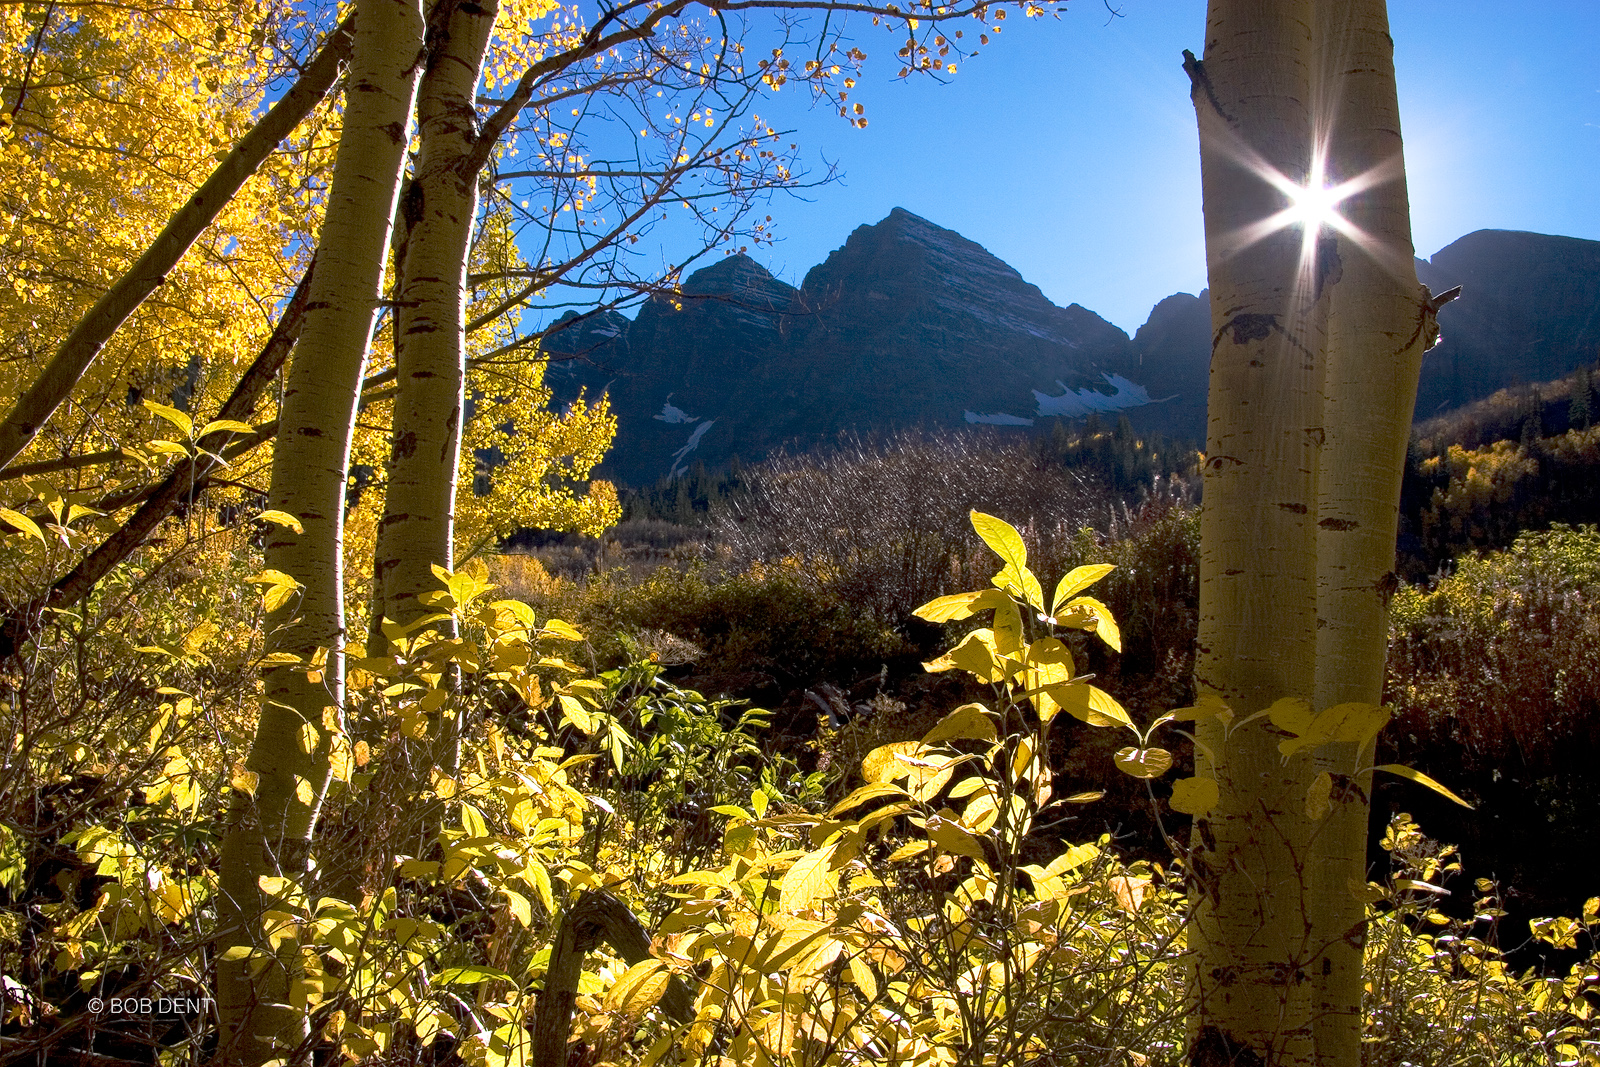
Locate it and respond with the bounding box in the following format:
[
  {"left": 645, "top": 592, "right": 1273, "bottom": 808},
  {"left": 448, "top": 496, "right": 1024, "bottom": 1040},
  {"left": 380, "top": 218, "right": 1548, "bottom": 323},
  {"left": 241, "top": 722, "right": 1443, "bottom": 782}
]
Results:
[{"left": 546, "top": 208, "right": 1600, "bottom": 485}]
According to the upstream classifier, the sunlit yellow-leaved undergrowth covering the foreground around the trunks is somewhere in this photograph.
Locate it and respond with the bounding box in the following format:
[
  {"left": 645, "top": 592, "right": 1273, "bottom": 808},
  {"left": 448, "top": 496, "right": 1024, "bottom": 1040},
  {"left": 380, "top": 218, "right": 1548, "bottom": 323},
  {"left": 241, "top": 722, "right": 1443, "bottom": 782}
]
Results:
[{"left": 0, "top": 504, "right": 1600, "bottom": 1067}]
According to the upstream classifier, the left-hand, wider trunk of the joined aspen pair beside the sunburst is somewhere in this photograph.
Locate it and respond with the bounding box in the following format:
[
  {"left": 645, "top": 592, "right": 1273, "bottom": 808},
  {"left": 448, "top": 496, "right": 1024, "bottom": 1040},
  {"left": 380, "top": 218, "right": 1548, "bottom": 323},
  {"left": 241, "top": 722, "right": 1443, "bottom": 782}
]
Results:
[{"left": 1187, "top": 0, "right": 1322, "bottom": 1067}]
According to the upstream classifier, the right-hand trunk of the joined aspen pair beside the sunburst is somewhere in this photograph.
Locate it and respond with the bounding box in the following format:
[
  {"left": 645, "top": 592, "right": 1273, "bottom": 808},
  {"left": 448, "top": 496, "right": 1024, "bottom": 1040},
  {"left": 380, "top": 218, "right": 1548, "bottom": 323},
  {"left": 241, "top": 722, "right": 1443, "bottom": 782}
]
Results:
[{"left": 1314, "top": 0, "right": 1434, "bottom": 1067}]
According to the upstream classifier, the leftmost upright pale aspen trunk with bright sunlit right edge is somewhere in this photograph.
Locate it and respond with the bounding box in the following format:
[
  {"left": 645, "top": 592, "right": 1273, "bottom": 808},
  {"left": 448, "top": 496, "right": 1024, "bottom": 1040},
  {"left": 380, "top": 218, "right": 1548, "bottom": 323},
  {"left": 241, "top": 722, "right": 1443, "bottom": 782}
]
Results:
[{"left": 218, "top": 0, "right": 424, "bottom": 1064}]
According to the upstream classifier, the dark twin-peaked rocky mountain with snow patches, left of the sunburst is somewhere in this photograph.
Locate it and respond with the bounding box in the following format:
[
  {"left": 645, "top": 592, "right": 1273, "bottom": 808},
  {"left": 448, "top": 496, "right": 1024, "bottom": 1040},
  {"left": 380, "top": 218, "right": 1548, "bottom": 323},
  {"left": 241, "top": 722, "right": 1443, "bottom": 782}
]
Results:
[{"left": 546, "top": 208, "right": 1149, "bottom": 485}]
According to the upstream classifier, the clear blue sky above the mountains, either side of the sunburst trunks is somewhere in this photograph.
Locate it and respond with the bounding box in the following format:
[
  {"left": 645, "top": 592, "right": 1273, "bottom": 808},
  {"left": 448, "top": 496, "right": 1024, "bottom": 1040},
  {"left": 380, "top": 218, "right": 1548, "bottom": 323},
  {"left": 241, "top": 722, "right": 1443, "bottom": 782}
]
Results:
[{"left": 704, "top": 0, "right": 1600, "bottom": 333}]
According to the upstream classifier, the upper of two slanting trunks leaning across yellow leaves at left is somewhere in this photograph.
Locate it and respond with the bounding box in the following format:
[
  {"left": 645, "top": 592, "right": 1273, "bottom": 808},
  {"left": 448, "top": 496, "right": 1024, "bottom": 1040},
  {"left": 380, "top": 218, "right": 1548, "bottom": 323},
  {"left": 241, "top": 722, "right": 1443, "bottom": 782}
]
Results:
[{"left": 0, "top": 21, "right": 350, "bottom": 469}]
